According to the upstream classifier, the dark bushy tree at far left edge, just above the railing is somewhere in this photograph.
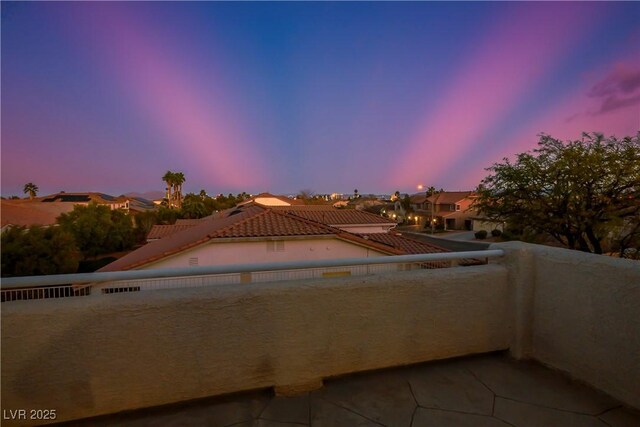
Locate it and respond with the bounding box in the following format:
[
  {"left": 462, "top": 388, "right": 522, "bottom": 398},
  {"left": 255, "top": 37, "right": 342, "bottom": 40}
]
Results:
[{"left": 2, "top": 227, "right": 80, "bottom": 276}]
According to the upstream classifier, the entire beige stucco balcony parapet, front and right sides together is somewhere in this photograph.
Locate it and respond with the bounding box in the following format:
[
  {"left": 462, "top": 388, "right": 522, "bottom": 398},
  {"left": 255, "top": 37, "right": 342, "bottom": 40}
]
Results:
[{"left": 2, "top": 242, "right": 640, "bottom": 425}]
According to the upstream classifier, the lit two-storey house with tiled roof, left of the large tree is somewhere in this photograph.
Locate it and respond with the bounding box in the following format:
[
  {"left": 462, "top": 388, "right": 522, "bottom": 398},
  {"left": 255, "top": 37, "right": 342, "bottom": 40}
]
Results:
[{"left": 411, "top": 191, "right": 477, "bottom": 230}]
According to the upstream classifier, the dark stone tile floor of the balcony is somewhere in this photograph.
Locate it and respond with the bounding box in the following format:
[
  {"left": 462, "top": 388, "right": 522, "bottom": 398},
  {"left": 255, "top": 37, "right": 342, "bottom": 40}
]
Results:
[{"left": 58, "top": 353, "right": 640, "bottom": 427}]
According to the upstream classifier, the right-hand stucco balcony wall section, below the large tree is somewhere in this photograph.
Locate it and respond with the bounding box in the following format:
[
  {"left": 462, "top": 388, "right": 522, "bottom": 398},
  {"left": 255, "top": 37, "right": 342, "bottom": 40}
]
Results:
[{"left": 491, "top": 242, "right": 640, "bottom": 408}]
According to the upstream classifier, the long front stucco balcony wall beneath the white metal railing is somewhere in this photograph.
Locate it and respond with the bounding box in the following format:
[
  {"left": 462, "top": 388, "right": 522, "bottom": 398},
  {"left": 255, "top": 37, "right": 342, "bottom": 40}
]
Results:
[{"left": 2, "top": 265, "right": 512, "bottom": 425}]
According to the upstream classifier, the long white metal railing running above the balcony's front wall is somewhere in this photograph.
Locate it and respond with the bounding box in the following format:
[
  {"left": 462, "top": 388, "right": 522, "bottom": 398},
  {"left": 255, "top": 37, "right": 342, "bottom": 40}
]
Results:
[{"left": 0, "top": 249, "right": 504, "bottom": 302}]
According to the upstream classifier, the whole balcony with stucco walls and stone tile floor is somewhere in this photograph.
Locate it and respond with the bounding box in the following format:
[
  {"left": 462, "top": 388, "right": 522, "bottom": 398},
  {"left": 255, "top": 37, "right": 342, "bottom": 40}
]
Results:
[{"left": 2, "top": 243, "right": 640, "bottom": 426}]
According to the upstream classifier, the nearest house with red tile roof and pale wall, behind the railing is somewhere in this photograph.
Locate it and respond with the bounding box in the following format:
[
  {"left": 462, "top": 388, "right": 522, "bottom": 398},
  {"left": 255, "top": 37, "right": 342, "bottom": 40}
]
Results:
[{"left": 100, "top": 203, "right": 446, "bottom": 271}]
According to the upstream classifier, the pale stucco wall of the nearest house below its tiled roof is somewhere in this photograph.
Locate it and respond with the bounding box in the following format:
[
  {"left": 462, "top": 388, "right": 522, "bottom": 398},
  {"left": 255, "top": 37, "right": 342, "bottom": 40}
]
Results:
[{"left": 144, "top": 237, "right": 383, "bottom": 269}]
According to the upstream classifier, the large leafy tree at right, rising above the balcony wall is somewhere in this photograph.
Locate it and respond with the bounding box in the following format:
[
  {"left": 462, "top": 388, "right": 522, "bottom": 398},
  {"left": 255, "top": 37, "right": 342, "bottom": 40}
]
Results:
[{"left": 474, "top": 133, "right": 640, "bottom": 253}]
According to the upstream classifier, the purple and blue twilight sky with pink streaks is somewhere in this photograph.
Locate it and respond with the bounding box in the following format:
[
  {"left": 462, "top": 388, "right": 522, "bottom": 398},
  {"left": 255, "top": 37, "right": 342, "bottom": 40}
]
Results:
[{"left": 0, "top": 1, "right": 640, "bottom": 197}]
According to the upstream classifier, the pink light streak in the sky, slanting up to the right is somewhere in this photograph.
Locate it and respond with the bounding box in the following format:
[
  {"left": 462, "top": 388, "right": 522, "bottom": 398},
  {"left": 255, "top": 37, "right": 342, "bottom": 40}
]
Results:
[{"left": 396, "top": 5, "right": 597, "bottom": 191}]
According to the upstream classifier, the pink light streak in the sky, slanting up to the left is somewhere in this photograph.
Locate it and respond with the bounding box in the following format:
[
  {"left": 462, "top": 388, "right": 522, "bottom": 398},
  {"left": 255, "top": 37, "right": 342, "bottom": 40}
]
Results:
[{"left": 69, "top": 5, "right": 265, "bottom": 188}]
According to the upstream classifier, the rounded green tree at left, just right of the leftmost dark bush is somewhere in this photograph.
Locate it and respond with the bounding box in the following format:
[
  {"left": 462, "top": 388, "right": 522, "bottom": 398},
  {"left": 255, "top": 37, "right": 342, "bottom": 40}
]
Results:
[{"left": 57, "top": 203, "right": 135, "bottom": 259}]
